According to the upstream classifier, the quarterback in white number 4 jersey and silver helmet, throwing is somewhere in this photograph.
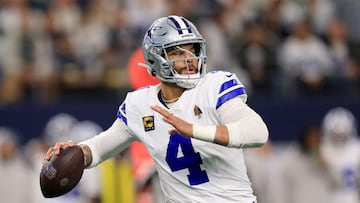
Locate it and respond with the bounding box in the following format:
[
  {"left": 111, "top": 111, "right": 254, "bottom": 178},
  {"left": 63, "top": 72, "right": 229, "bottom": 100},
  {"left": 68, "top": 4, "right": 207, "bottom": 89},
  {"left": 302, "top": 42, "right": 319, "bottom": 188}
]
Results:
[{"left": 44, "top": 16, "right": 268, "bottom": 203}]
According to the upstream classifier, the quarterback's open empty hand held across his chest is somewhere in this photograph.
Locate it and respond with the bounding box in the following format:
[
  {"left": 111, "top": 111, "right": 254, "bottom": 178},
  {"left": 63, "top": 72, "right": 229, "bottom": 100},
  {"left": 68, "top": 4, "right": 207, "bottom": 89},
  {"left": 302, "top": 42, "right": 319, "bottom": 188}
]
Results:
[{"left": 151, "top": 105, "right": 193, "bottom": 137}]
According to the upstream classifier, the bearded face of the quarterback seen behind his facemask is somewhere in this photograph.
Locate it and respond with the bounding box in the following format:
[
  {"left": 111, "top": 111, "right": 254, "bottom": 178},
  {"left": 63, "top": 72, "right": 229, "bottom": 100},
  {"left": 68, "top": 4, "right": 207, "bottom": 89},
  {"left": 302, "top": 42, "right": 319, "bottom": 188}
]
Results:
[{"left": 167, "top": 44, "right": 198, "bottom": 75}]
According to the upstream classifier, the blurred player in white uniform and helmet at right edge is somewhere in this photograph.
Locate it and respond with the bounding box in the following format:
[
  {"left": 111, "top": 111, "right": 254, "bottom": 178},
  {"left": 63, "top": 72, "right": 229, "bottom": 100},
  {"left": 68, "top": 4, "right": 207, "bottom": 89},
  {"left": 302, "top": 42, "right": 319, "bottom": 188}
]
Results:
[{"left": 321, "top": 107, "right": 360, "bottom": 203}]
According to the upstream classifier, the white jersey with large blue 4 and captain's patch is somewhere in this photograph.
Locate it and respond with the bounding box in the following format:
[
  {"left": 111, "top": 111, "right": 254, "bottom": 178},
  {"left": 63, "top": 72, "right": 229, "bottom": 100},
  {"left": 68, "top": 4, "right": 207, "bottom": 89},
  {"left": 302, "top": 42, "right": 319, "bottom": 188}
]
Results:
[{"left": 118, "top": 71, "right": 255, "bottom": 203}]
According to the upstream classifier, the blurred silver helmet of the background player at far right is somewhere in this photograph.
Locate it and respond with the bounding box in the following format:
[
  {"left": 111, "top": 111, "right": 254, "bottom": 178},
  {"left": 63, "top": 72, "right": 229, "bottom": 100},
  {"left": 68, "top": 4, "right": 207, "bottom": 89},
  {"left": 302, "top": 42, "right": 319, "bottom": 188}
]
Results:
[{"left": 322, "top": 107, "right": 357, "bottom": 142}]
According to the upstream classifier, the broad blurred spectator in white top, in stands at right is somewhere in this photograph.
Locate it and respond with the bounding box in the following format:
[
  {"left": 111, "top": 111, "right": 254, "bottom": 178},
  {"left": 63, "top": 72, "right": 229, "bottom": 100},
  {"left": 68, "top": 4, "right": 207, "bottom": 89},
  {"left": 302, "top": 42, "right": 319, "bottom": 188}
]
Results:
[{"left": 278, "top": 19, "right": 333, "bottom": 97}]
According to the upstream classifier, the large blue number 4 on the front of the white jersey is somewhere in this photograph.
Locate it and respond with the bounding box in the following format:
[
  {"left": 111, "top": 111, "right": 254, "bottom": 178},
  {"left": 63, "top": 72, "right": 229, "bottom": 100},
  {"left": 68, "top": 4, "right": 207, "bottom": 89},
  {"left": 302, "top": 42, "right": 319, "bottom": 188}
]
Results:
[{"left": 166, "top": 134, "right": 209, "bottom": 185}]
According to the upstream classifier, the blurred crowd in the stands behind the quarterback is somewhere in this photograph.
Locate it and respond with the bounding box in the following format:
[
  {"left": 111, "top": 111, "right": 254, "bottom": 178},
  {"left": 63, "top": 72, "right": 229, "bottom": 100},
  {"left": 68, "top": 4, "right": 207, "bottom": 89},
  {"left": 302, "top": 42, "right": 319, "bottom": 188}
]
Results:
[{"left": 0, "top": 0, "right": 360, "bottom": 103}]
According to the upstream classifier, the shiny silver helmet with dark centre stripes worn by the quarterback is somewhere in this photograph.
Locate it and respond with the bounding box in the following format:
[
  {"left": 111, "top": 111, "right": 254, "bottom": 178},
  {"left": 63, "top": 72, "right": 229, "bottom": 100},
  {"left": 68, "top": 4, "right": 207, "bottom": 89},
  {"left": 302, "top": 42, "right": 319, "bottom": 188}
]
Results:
[{"left": 142, "top": 16, "right": 206, "bottom": 89}]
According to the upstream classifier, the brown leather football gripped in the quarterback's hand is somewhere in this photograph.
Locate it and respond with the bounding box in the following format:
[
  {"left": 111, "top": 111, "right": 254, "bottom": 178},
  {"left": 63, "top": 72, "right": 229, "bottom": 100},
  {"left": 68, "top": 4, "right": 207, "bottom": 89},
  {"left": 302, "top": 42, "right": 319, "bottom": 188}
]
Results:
[{"left": 40, "top": 146, "right": 85, "bottom": 198}]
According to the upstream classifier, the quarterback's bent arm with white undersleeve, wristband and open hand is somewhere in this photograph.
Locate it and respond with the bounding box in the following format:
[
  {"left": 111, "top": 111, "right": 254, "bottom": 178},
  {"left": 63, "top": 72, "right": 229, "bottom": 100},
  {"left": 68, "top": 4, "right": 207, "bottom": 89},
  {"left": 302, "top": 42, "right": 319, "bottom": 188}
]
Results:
[{"left": 152, "top": 97, "right": 268, "bottom": 148}]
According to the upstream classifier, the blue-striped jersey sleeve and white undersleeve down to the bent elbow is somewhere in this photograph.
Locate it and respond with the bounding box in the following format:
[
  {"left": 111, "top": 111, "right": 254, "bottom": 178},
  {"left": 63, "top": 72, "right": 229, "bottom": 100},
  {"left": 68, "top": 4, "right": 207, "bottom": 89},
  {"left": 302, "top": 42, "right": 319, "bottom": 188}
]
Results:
[{"left": 210, "top": 72, "right": 268, "bottom": 148}]
